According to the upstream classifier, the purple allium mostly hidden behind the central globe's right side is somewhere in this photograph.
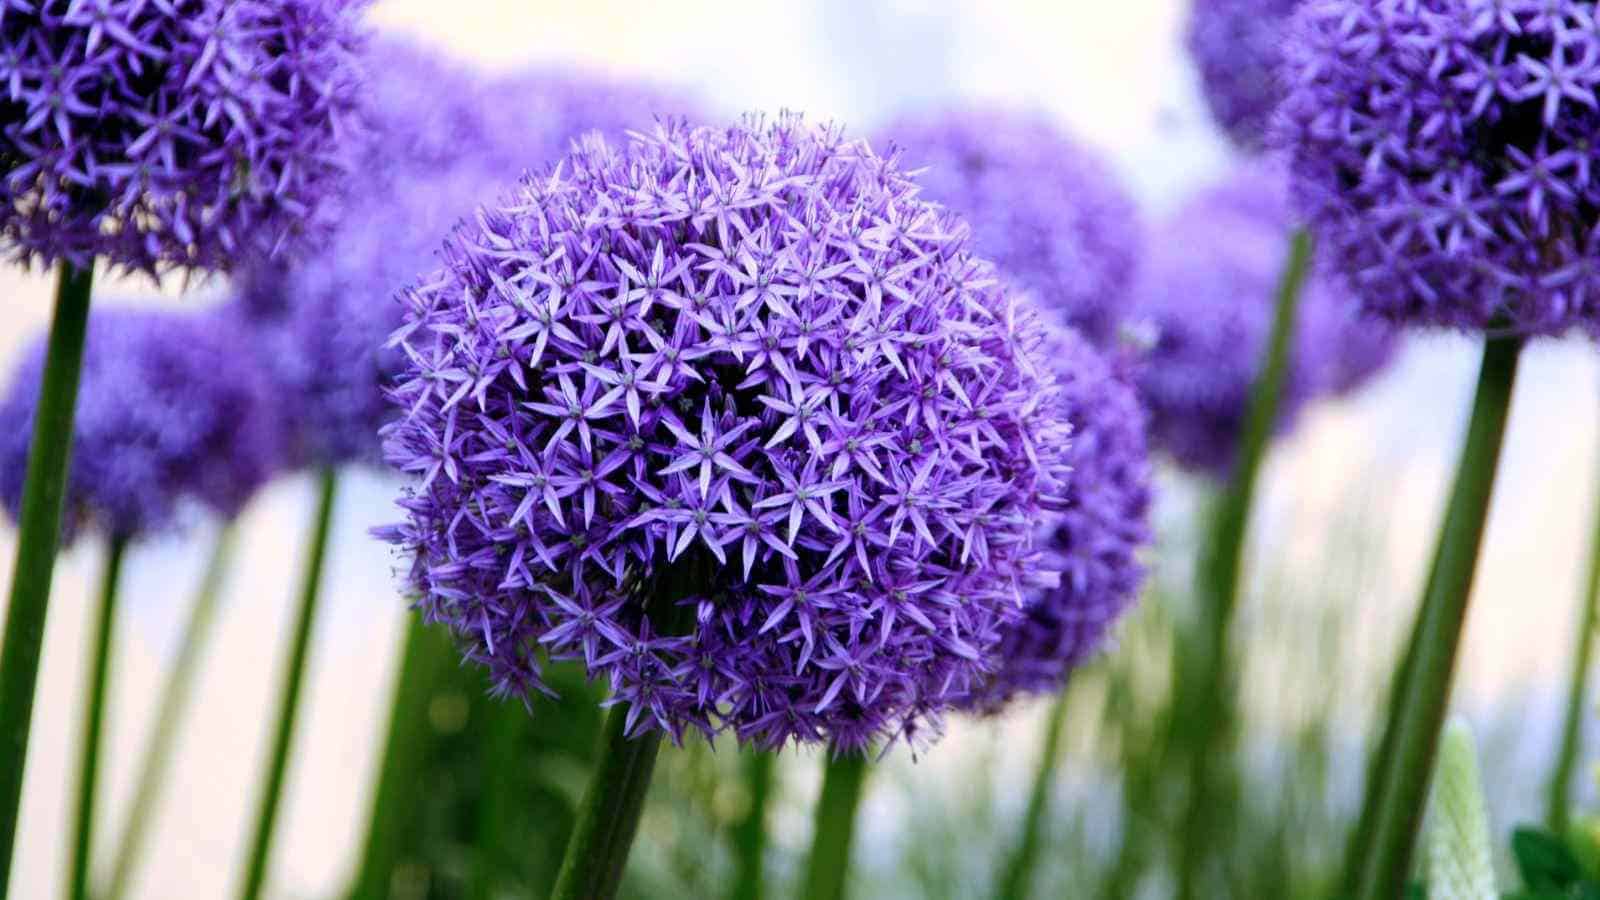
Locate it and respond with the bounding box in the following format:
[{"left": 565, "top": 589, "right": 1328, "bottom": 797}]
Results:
[{"left": 966, "top": 321, "right": 1150, "bottom": 711}]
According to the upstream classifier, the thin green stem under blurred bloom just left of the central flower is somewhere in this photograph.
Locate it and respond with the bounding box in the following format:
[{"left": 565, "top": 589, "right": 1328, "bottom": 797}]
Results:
[{"left": 238, "top": 468, "right": 338, "bottom": 900}]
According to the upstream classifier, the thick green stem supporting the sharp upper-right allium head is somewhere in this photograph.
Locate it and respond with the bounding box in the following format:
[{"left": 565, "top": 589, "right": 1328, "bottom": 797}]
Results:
[{"left": 1350, "top": 336, "right": 1522, "bottom": 900}]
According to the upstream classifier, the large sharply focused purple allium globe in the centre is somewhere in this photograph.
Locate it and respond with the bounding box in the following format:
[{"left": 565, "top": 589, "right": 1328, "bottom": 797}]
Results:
[{"left": 376, "top": 115, "right": 1069, "bottom": 749}]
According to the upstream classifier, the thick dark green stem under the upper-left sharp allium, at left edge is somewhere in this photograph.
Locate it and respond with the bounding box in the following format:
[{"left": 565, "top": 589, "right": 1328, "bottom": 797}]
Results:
[{"left": 0, "top": 263, "right": 94, "bottom": 900}]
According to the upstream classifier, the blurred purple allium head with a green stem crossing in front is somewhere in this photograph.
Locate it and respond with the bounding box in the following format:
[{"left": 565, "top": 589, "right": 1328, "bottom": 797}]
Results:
[{"left": 1136, "top": 162, "right": 1397, "bottom": 476}]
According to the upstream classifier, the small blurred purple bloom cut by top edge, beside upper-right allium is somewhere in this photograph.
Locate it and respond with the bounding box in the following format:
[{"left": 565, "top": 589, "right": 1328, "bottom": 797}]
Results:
[{"left": 1189, "top": 0, "right": 1299, "bottom": 149}]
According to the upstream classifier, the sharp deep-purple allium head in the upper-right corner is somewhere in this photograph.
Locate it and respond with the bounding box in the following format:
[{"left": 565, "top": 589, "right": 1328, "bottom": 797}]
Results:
[{"left": 1275, "top": 0, "right": 1600, "bottom": 335}]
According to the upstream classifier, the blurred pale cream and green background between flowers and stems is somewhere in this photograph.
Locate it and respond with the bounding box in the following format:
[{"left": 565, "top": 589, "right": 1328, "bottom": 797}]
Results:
[{"left": 0, "top": 0, "right": 1600, "bottom": 898}]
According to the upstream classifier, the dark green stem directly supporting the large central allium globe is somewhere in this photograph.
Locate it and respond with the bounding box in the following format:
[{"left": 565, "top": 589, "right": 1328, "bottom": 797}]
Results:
[{"left": 550, "top": 705, "right": 661, "bottom": 900}]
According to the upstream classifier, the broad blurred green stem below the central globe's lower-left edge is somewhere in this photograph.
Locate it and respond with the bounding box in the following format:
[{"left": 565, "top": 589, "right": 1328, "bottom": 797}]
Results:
[{"left": 350, "top": 613, "right": 450, "bottom": 900}]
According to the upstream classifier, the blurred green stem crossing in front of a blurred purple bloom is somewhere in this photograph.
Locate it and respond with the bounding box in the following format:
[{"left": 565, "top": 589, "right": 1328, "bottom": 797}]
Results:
[{"left": 1178, "top": 229, "right": 1310, "bottom": 900}]
